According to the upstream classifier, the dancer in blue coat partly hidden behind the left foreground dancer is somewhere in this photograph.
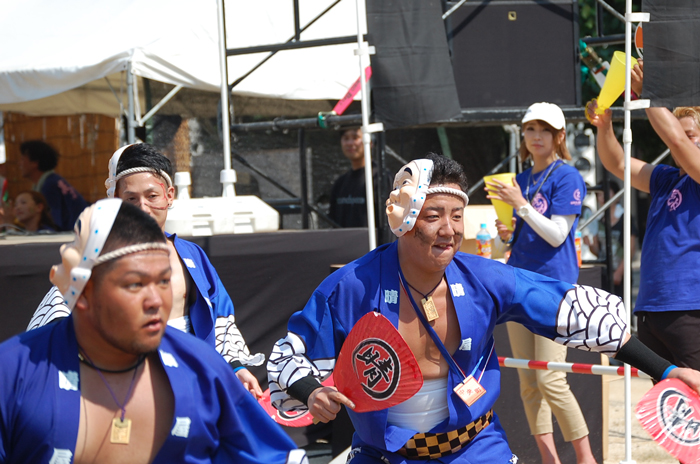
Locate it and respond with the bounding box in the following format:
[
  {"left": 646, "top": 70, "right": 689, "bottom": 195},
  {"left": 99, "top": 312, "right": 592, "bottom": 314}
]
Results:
[{"left": 28, "top": 143, "right": 265, "bottom": 397}]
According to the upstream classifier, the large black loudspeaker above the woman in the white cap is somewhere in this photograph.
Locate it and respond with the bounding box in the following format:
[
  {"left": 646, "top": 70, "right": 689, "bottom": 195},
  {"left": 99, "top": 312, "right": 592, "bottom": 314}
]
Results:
[{"left": 447, "top": 0, "right": 581, "bottom": 109}]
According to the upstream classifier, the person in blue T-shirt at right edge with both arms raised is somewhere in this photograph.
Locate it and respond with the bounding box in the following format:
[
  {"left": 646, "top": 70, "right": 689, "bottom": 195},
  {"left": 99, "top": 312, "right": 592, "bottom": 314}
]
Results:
[{"left": 587, "top": 61, "right": 700, "bottom": 369}]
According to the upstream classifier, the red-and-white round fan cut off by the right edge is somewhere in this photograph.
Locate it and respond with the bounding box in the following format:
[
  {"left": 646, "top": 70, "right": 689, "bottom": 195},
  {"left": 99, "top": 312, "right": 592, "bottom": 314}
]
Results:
[{"left": 636, "top": 379, "right": 700, "bottom": 464}]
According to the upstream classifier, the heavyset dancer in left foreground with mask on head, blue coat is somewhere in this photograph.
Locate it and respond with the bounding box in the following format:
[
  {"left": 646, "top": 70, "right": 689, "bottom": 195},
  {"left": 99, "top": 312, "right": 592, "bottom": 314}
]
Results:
[{"left": 0, "top": 199, "right": 308, "bottom": 464}]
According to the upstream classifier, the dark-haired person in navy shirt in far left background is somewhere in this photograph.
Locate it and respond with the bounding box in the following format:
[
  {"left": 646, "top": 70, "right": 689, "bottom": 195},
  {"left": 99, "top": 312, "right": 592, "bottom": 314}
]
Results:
[{"left": 19, "top": 140, "right": 88, "bottom": 231}]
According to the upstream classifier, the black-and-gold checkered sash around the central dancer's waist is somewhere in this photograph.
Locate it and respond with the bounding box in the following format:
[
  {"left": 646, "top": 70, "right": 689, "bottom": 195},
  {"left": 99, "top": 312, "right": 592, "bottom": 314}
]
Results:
[{"left": 397, "top": 409, "right": 493, "bottom": 459}]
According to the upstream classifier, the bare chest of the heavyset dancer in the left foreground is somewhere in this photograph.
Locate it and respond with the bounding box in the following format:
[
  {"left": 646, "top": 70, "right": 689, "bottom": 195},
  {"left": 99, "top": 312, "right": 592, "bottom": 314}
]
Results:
[{"left": 74, "top": 362, "right": 174, "bottom": 464}]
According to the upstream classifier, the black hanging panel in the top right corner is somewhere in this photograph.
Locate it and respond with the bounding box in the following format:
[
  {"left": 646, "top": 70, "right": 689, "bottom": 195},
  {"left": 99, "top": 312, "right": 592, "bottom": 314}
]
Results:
[{"left": 642, "top": 0, "right": 700, "bottom": 108}]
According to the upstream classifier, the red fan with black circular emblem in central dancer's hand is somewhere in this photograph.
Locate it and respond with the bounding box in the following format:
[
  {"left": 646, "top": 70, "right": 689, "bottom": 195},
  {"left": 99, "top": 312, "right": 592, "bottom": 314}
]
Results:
[{"left": 334, "top": 311, "right": 423, "bottom": 412}]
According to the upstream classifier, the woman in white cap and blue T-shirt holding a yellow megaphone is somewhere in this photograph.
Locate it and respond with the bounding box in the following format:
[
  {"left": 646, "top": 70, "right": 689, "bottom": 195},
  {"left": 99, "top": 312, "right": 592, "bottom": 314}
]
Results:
[{"left": 486, "top": 103, "right": 596, "bottom": 464}]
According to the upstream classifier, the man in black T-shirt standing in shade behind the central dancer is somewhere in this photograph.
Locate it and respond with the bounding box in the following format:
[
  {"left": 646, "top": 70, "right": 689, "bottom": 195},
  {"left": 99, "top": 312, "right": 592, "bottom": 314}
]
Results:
[{"left": 328, "top": 127, "right": 391, "bottom": 227}]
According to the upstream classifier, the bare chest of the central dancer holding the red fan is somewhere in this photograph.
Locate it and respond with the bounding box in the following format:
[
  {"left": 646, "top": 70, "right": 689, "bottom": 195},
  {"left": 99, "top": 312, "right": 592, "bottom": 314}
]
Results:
[{"left": 399, "top": 281, "right": 460, "bottom": 379}]
